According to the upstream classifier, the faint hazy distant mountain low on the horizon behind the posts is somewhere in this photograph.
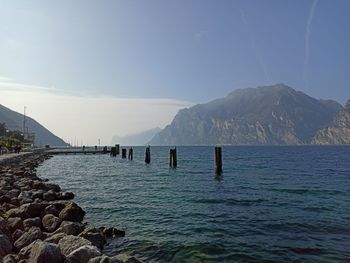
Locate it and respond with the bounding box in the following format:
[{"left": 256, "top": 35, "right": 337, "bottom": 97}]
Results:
[{"left": 112, "top": 127, "right": 162, "bottom": 146}]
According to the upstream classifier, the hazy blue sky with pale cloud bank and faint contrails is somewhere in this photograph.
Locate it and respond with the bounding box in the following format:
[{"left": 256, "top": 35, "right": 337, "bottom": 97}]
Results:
[{"left": 0, "top": 0, "right": 350, "bottom": 145}]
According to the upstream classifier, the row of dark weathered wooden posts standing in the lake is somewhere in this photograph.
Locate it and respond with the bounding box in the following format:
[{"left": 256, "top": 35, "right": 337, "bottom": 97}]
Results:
[{"left": 111, "top": 144, "right": 222, "bottom": 174}]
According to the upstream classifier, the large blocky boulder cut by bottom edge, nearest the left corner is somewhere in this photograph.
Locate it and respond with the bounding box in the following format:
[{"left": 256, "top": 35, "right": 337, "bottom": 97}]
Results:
[{"left": 28, "top": 241, "right": 64, "bottom": 263}]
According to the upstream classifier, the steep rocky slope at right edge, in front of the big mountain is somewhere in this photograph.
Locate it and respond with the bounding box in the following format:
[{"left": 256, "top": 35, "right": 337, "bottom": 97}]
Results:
[{"left": 312, "top": 100, "right": 350, "bottom": 144}]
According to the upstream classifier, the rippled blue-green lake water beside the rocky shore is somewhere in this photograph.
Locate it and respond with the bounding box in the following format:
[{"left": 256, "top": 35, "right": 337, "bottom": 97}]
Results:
[{"left": 38, "top": 146, "right": 350, "bottom": 262}]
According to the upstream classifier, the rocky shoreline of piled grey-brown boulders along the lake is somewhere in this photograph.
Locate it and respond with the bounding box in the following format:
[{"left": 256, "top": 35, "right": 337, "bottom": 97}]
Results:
[{"left": 0, "top": 153, "right": 139, "bottom": 263}]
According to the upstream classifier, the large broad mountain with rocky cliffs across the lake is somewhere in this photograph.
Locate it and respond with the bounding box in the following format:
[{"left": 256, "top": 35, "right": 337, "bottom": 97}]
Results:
[{"left": 150, "top": 84, "right": 342, "bottom": 145}]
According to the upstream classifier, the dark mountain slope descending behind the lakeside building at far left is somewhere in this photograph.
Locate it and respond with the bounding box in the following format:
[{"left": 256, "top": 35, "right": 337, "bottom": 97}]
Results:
[{"left": 0, "top": 104, "right": 68, "bottom": 146}]
